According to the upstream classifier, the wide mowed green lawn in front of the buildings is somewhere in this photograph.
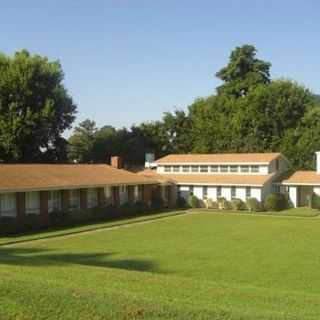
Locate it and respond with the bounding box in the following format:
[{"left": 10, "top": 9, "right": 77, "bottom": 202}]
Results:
[{"left": 0, "top": 212, "right": 320, "bottom": 320}]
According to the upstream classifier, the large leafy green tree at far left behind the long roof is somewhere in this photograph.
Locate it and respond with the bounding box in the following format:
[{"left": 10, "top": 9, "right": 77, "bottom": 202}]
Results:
[{"left": 0, "top": 50, "right": 76, "bottom": 162}]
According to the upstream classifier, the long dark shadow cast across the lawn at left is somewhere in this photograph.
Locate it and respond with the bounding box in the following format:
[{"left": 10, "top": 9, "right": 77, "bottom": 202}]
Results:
[{"left": 0, "top": 248, "right": 161, "bottom": 273}]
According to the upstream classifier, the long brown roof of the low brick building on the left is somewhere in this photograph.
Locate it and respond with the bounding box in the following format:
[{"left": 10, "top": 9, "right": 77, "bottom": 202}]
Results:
[{"left": 0, "top": 164, "right": 156, "bottom": 192}]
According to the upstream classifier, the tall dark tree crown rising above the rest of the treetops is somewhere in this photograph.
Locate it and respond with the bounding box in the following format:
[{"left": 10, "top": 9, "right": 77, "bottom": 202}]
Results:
[{"left": 216, "top": 45, "right": 271, "bottom": 98}]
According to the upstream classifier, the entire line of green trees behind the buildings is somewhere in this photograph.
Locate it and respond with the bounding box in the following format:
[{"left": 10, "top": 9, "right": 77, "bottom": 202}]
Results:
[{"left": 0, "top": 45, "right": 320, "bottom": 169}]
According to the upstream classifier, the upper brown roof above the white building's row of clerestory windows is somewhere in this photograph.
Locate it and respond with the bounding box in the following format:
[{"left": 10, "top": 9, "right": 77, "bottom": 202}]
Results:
[{"left": 156, "top": 153, "right": 281, "bottom": 164}]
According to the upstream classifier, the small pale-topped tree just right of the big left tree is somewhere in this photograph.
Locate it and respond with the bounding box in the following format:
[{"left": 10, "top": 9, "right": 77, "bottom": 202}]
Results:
[{"left": 69, "top": 119, "right": 97, "bottom": 162}]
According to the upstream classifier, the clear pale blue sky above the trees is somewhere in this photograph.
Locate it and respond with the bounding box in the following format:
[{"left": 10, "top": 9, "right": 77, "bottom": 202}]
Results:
[{"left": 0, "top": 0, "right": 320, "bottom": 132}]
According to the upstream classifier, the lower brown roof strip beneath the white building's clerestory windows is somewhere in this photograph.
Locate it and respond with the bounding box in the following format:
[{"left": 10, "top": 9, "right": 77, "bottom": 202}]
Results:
[{"left": 144, "top": 174, "right": 274, "bottom": 186}]
